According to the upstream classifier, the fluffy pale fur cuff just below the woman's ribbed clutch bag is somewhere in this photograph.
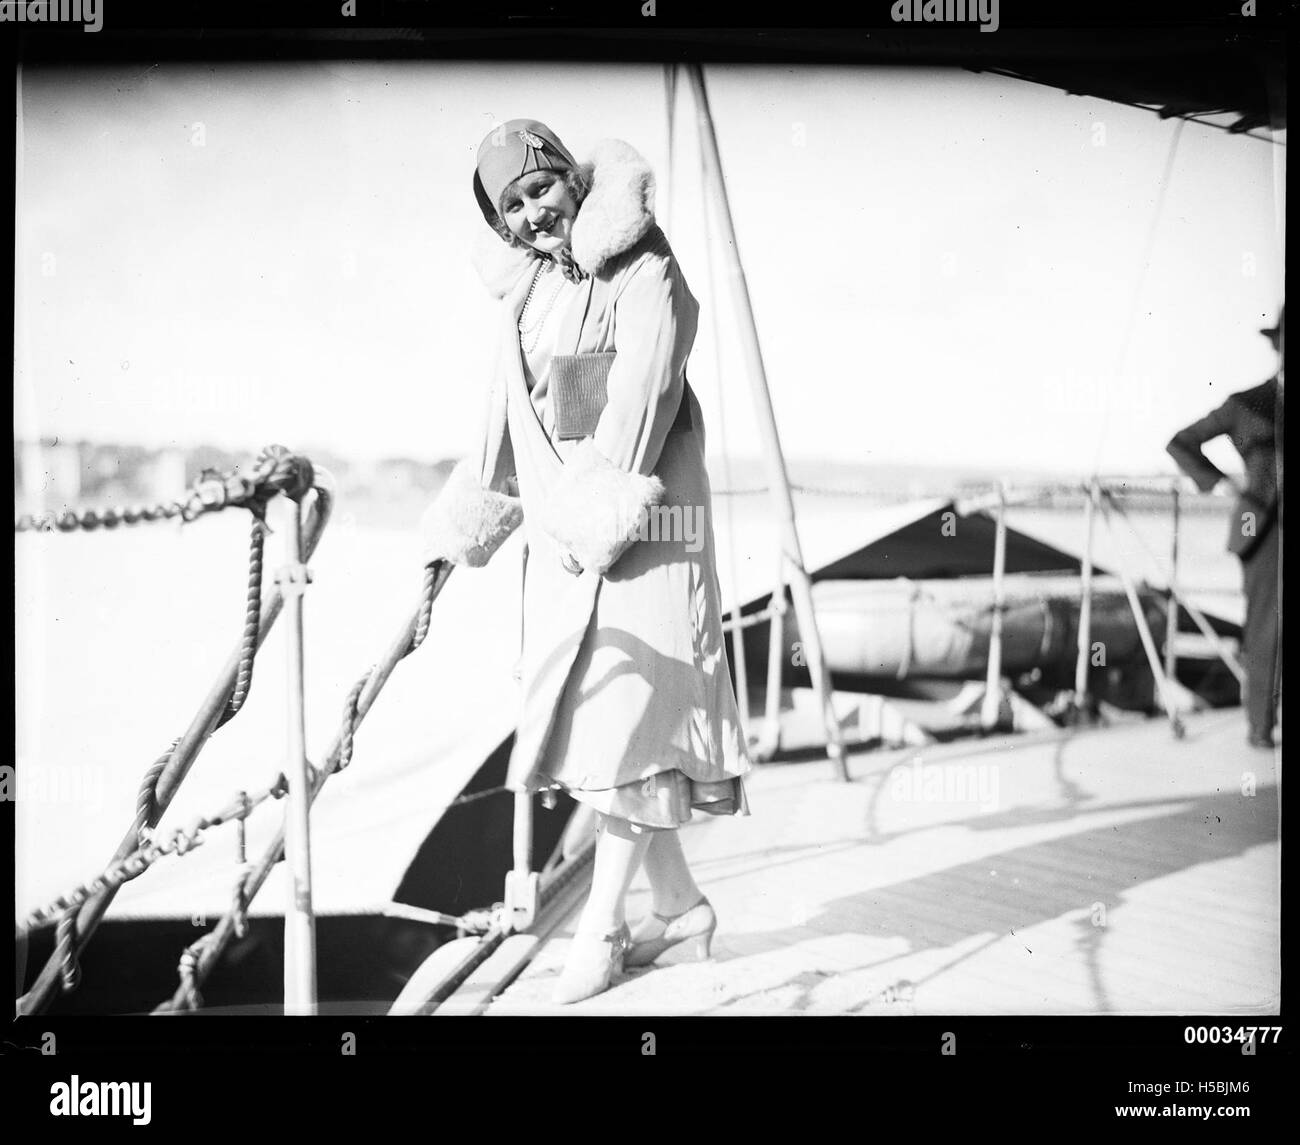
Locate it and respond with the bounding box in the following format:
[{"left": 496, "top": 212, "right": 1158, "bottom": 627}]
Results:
[{"left": 541, "top": 438, "right": 664, "bottom": 576}]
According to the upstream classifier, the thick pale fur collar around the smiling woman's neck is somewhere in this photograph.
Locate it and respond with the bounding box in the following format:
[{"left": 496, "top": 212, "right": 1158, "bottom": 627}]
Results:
[{"left": 473, "top": 139, "right": 654, "bottom": 298}]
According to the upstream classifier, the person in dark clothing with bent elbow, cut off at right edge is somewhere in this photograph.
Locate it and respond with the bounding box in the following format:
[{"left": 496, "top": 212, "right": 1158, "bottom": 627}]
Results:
[{"left": 1167, "top": 312, "right": 1284, "bottom": 747}]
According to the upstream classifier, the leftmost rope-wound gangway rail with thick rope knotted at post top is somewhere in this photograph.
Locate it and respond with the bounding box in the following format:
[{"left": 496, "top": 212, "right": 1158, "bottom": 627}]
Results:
[{"left": 16, "top": 446, "right": 333, "bottom": 1014}]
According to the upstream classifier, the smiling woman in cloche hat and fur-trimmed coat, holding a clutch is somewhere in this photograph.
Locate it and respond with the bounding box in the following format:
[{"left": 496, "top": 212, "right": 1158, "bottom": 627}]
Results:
[{"left": 424, "top": 120, "right": 750, "bottom": 1002}]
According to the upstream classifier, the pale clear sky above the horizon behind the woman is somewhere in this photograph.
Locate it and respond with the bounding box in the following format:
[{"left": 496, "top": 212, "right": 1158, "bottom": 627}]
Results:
[{"left": 14, "top": 61, "right": 1286, "bottom": 474}]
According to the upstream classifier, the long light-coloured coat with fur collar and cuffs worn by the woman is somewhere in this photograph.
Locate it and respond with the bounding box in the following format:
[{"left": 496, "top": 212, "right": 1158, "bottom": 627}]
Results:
[{"left": 424, "top": 140, "right": 750, "bottom": 790}]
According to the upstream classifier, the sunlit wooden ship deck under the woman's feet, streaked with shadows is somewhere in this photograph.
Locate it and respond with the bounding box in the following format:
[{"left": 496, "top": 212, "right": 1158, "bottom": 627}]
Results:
[{"left": 485, "top": 711, "right": 1281, "bottom": 1015}]
